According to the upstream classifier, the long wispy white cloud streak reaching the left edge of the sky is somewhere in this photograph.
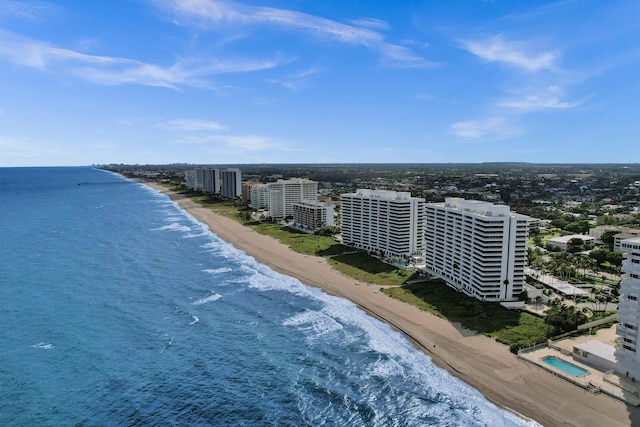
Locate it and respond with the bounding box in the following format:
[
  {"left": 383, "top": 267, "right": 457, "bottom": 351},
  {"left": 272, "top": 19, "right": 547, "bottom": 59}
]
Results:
[{"left": 0, "top": 30, "right": 288, "bottom": 88}]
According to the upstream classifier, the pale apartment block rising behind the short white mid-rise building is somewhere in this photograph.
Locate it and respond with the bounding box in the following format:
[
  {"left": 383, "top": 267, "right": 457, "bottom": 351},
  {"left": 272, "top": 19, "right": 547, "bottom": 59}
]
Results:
[{"left": 267, "top": 178, "right": 318, "bottom": 220}]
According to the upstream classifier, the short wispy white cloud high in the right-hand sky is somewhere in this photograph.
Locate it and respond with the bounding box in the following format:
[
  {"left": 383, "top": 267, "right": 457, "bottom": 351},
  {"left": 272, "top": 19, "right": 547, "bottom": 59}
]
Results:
[{"left": 463, "top": 35, "right": 560, "bottom": 72}]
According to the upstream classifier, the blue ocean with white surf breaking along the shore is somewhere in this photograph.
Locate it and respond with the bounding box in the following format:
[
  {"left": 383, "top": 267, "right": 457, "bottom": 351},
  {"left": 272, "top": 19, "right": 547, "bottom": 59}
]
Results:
[{"left": 0, "top": 167, "right": 536, "bottom": 426}]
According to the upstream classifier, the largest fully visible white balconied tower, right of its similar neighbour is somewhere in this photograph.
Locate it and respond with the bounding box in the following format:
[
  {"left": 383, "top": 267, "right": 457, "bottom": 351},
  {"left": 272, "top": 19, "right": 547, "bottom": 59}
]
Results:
[{"left": 425, "top": 197, "right": 529, "bottom": 301}]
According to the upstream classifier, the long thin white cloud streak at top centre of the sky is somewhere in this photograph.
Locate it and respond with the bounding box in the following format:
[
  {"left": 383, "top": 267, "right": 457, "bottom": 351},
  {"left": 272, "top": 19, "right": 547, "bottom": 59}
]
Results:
[{"left": 155, "top": 0, "right": 435, "bottom": 67}]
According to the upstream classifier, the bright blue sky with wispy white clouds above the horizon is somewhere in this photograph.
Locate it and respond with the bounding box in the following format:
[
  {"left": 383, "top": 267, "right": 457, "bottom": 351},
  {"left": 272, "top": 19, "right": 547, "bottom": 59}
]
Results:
[{"left": 0, "top": 0, "right": 640, "bottom": 166}]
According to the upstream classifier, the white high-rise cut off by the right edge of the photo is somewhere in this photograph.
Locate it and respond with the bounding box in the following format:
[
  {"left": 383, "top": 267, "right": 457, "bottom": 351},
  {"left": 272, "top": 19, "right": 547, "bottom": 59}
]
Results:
[{"left": 615, "top": 237, "right": 640, "bottom": 379}]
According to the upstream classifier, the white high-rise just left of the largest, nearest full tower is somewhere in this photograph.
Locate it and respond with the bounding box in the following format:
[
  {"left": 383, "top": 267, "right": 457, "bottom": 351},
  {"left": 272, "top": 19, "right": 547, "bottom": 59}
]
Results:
[{"left": 340, "top": 189, "right": 425, "bottom": 259}]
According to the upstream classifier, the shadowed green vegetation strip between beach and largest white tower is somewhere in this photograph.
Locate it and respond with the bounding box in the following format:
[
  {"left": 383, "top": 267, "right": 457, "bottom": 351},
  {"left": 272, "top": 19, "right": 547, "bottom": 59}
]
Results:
[{"left": 382, "top": 281, "right": 548, "bottom": 352}]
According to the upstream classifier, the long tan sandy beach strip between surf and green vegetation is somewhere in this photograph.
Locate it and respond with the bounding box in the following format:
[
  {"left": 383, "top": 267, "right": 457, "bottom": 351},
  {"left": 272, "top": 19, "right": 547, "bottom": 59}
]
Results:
[{"left": 144, "top": 182, "right": 640, "bottom": 427}]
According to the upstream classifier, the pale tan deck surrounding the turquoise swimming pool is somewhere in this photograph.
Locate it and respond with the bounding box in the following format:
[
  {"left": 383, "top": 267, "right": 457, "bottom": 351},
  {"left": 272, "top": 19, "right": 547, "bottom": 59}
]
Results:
[{"left": 518, "top": 331, "right": 640, "bottom": 406}]
